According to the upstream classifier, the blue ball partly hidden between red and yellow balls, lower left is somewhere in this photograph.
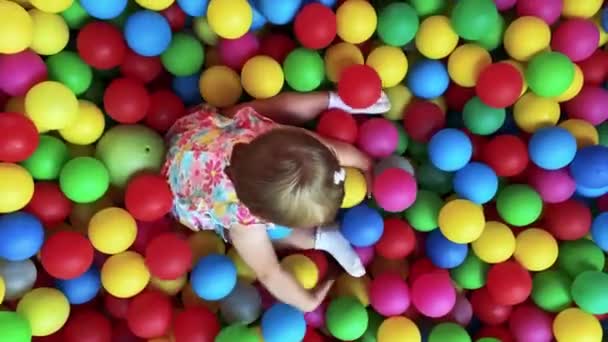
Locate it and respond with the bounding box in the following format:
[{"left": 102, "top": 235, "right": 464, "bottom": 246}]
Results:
[{"left": 55, "top": 266, "right": 101, "bottom": 304}]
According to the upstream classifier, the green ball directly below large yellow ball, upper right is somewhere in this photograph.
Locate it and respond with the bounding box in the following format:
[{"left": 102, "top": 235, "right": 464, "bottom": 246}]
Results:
[{"left": 525, "top": 51, "right": 574, "bottom": 97}]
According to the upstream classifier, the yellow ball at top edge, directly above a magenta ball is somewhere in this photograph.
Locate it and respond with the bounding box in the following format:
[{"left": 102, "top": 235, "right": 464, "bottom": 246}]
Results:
[{"left": 207, "top": 0, "right": 253, "bottom": 39}]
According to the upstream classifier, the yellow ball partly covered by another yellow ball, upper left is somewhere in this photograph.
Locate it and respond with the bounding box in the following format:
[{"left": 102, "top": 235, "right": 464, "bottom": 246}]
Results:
[{"left": 59, "top": 100, "right": 106, "bottom": 145}]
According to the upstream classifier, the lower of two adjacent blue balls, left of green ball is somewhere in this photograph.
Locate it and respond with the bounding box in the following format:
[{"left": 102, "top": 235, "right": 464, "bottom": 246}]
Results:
[{"left": 453, "top": 162, "right": 498, "bottom": 204}]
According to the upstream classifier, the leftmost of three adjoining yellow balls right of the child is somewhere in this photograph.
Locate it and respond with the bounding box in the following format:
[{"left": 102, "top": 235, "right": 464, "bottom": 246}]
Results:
[{"left": 439, "top": 199, "right": 486, "bottom": 243}]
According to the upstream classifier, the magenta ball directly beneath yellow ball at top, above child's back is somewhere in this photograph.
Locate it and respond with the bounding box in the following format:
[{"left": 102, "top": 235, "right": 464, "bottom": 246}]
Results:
[{"left": 217, "top": 32, "right": 260, "bottom": 71}]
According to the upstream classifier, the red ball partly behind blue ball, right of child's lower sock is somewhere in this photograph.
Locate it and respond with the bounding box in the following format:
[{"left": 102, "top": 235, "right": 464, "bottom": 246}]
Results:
[{"left": 375, "top": 218, "right": 416, "bottom": 260}]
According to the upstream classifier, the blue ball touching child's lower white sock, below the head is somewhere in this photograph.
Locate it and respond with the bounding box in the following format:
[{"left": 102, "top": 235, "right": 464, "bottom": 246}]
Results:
[{"left": 340, "top": 204, "right": 384, "bottom": 247}]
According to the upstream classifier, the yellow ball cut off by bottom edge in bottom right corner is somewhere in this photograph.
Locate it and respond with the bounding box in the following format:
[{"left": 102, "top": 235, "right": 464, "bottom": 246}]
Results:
[{"left": 553, "top": 308, "right": 603, "bottom": 342}]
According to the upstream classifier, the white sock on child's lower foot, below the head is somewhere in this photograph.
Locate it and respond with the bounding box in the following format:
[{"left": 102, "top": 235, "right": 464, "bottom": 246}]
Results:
[{"left": 315, "top": 224, "right": 365, "bottom": 277}]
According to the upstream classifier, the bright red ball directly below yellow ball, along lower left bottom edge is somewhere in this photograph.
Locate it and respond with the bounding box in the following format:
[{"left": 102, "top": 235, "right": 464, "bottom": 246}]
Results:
[{"left": 127, "top": 290, "right": 173, "bottom": 338}]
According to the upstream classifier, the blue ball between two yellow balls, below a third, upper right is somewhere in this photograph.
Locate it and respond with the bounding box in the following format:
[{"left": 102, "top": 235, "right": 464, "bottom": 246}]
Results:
[{"left": 407, "top": 59, "right": 450, "bottom": 99}]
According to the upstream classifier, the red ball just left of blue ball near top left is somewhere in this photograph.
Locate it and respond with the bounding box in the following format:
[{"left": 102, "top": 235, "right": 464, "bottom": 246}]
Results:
[{"left": 76, "top": 21, "right": 127, "bottom": 69}]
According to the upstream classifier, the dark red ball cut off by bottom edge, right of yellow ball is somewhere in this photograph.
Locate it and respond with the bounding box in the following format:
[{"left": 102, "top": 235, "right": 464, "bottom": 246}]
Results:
[{"left": 63, "top": 309, "right": 112, "bottom": 342}]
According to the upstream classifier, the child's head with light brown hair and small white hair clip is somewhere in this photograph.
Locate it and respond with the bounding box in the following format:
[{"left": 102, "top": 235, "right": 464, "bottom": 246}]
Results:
[{"left": 230, "top": 128, "right": 344, "bottom": 228}]
